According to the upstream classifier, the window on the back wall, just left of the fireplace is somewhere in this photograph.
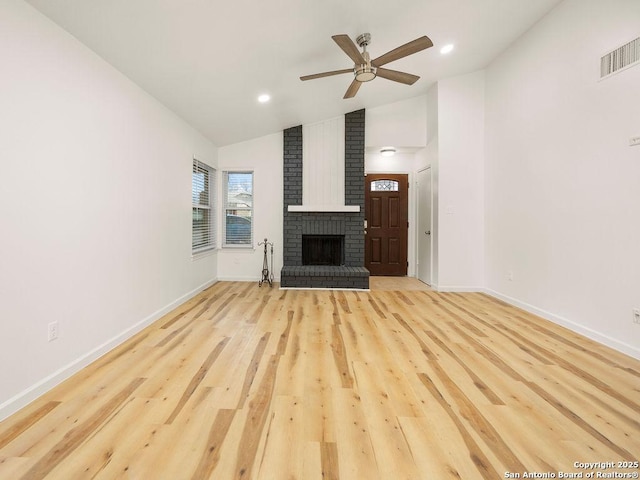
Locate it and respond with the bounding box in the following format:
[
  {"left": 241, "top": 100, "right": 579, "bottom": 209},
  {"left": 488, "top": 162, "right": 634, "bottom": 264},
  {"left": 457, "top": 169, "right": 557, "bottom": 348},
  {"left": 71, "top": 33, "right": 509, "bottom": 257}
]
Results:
[{"left": 224, "top": 172, "right": 253, "bottom": 247}]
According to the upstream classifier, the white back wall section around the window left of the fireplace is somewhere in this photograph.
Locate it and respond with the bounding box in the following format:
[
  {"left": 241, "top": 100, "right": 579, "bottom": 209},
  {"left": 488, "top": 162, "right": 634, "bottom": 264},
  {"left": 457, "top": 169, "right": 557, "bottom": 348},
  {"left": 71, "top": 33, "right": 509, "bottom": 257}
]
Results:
[{"left": 218, "top": 132, "right": 284, "bottom": 282}]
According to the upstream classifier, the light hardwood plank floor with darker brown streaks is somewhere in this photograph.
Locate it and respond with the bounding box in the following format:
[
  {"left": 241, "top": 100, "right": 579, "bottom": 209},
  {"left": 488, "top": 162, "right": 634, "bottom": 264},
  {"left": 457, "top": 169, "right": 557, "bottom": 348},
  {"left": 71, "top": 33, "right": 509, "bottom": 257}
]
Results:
[{"left": 0, "top": 282, "right": 640, "bottom": 480}]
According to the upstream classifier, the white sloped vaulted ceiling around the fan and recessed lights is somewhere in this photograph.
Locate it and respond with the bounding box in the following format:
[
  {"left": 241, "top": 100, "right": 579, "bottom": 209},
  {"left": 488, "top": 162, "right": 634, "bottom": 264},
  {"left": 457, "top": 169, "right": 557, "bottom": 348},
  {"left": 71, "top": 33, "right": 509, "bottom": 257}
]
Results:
[{"left": 27, "top": 0, "right": 560, "bottom": 146}]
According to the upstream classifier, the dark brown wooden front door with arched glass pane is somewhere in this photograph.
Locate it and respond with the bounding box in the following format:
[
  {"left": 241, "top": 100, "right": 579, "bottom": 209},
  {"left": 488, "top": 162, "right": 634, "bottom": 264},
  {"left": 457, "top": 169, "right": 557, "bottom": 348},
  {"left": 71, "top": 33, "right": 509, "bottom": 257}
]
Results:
[{"left": 364, "top": 173, "right": 409, "bottom": 276}]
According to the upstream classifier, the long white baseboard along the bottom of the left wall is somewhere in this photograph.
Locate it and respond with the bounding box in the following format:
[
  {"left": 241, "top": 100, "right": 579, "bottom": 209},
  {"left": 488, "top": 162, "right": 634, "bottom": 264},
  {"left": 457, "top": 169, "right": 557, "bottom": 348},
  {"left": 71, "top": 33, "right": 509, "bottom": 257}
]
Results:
[{"left": 0, "top": 279, "right": 218, "bottom": 421}]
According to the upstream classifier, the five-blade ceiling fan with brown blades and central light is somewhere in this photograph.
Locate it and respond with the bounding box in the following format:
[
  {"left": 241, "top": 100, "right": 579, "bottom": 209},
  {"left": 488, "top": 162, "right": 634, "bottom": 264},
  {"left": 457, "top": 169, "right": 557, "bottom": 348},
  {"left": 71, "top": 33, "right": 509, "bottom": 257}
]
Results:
[{"left": 300, "top": 33, "right": 433, "bottom": 98}]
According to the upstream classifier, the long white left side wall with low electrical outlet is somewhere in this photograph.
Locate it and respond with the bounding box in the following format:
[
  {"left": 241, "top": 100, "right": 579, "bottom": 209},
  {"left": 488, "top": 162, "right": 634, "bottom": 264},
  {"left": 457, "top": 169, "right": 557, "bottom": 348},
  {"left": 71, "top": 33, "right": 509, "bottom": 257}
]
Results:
[{"left": 0, "top": 0, "right": 216, "bottom": 418}]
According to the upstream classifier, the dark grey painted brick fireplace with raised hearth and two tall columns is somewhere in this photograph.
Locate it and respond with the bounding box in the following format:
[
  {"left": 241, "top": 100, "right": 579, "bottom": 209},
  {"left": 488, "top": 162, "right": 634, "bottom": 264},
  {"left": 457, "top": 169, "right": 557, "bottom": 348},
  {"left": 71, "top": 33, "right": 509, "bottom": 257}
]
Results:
[{"left": 280, "top": 110, "right": 369, "bottom": 289}]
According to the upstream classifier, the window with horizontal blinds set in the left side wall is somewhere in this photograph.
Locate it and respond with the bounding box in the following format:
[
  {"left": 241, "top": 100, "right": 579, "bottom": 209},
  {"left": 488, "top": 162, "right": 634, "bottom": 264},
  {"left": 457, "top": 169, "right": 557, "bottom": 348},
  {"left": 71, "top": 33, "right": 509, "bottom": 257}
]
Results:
[{"left": 191, "top": 158, "right": 216, "bottom": 253}]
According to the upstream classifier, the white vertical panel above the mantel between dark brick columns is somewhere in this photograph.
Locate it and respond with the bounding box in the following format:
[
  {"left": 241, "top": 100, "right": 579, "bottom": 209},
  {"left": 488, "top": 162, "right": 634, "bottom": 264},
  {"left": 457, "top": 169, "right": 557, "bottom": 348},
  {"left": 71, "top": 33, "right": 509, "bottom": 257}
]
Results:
[{"left": 302, "top": 116, "right": 344, "bottom": 206}]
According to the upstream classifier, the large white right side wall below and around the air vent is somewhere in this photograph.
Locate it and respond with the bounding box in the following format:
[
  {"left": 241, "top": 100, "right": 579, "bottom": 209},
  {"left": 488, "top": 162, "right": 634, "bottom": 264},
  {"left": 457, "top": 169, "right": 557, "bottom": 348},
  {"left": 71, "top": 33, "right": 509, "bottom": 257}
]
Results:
[{"left": 486, "top": 0, "right": 640, "bottom": 358}]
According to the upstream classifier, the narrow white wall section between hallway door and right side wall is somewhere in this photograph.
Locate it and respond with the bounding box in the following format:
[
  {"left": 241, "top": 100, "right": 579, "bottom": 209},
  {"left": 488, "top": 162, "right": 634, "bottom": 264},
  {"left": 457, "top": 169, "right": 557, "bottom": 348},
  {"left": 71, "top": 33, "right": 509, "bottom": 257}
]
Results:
[{"left": 435, "top": 71, "right": 485, "bottom": 290}]
